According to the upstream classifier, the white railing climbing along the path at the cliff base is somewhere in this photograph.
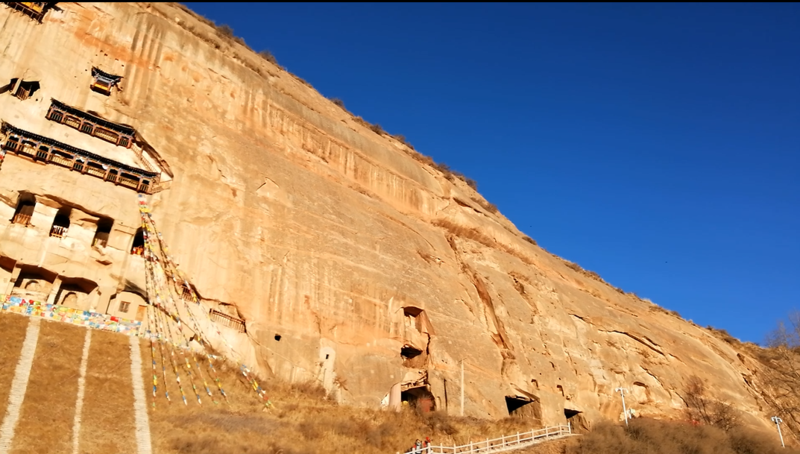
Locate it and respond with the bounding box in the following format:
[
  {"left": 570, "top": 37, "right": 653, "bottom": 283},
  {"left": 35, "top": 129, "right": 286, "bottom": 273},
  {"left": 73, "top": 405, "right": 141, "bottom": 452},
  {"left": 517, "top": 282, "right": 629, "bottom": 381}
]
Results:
[{"left": 405, "top": 423, "right": 572, "bottom": 454}]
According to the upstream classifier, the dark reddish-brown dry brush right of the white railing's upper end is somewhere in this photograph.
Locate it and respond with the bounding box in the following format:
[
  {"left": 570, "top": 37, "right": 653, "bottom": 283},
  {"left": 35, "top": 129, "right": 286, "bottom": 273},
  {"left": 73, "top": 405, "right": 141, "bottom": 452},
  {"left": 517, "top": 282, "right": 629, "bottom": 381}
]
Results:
[{"left": 565, "top": 419, "right": 800, "bottom": 454}]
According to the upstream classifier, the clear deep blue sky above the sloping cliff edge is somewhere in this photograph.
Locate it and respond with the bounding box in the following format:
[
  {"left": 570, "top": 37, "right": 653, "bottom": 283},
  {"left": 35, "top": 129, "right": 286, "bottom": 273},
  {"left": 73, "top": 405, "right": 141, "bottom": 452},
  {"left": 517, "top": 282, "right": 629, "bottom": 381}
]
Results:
[{"left": 187, "top": 3, "right": 800, "bottom": 342}]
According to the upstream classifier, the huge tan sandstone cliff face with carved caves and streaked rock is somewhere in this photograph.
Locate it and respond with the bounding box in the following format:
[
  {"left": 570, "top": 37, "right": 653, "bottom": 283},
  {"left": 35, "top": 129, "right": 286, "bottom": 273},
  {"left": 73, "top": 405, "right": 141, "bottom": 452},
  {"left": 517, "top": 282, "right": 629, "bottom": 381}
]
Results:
[{"left": 0, "top": 3, "right": 780, "bottom": 432}]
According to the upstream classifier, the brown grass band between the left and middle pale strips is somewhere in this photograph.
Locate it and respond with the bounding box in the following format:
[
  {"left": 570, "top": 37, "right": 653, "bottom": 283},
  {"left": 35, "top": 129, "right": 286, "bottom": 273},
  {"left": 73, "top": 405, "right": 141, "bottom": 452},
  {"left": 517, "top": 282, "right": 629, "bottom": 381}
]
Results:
[{"left": 12, "top": 320, "right": 86, "bottom": 453}]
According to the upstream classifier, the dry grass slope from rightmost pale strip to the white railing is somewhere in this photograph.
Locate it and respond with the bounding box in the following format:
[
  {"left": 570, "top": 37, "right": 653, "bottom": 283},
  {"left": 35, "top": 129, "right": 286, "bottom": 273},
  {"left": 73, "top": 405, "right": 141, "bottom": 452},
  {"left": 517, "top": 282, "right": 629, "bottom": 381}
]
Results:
[{"left": 143, "top": 345, "right": 552, "bottom": 454}]
